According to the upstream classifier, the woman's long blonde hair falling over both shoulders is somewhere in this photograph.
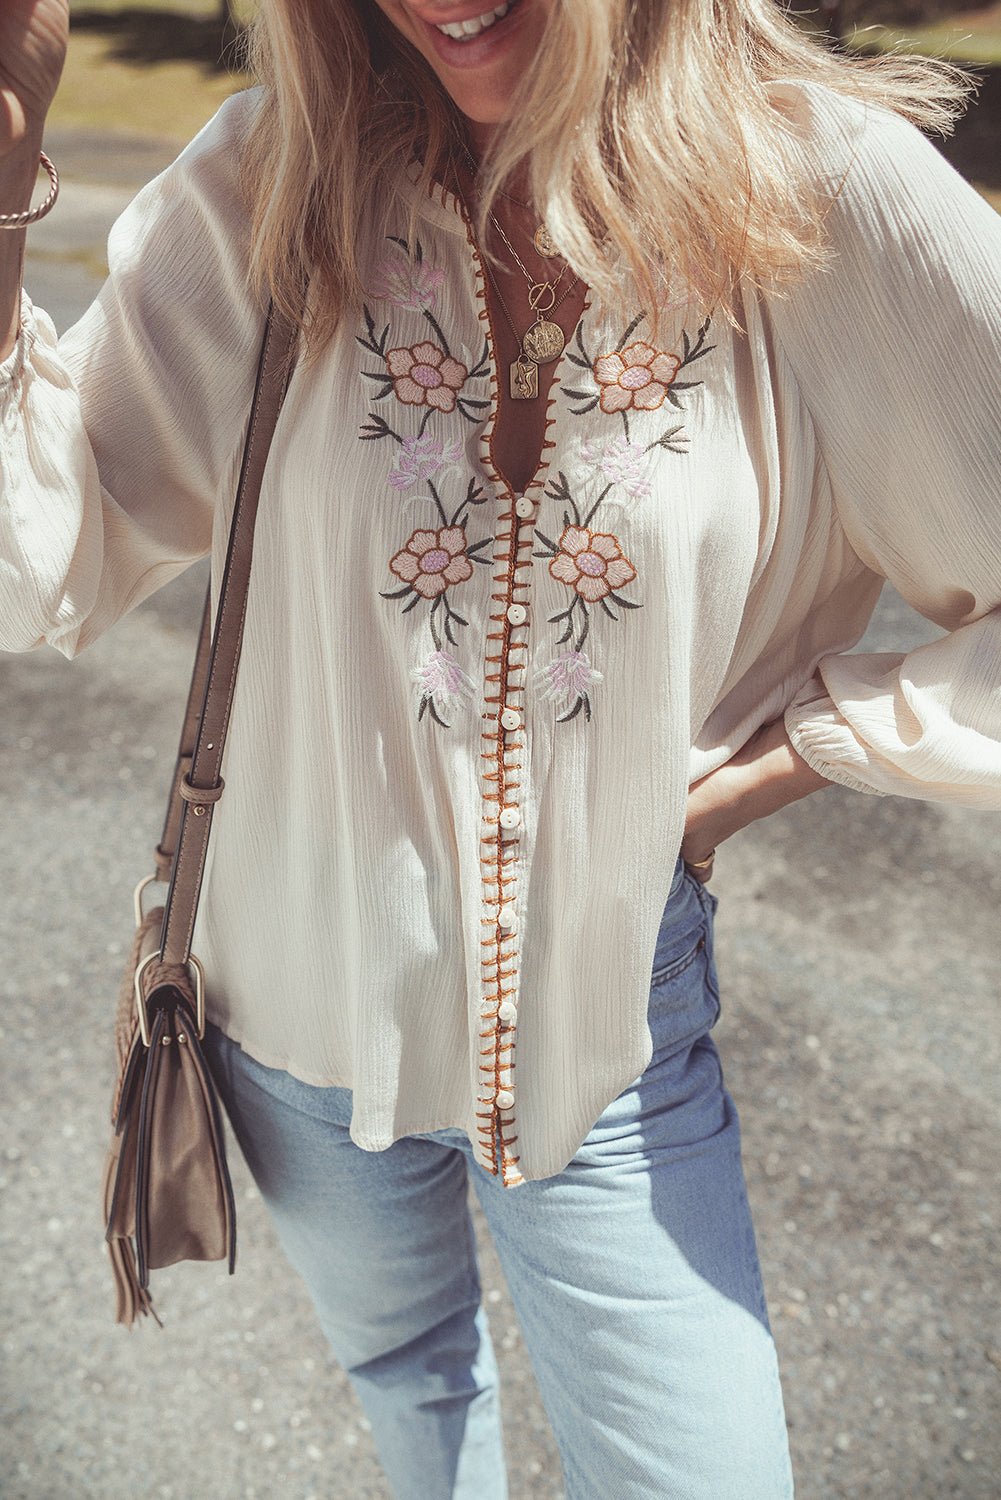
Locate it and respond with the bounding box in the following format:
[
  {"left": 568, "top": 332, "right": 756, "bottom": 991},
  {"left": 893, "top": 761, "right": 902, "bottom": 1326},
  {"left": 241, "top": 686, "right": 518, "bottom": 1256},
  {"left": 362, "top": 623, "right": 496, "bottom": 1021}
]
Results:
[{"left": 243, "top": 0, "right": 968, "bottom": 353}]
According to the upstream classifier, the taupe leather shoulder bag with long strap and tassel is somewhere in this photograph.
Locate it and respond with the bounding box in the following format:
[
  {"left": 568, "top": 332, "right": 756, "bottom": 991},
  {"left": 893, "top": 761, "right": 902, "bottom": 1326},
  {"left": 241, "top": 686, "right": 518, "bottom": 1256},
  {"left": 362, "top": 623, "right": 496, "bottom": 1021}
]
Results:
[{"left": 104, "top": 308, "right": 297, "bottom": 1325}]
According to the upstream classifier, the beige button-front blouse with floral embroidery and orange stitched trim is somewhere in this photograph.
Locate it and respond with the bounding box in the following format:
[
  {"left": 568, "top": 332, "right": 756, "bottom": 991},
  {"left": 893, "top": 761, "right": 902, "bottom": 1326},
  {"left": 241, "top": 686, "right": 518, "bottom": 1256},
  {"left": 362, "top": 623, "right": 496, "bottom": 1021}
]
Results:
[{"left": 0, "top": 86, "right": 1001, "bottom": 1184}]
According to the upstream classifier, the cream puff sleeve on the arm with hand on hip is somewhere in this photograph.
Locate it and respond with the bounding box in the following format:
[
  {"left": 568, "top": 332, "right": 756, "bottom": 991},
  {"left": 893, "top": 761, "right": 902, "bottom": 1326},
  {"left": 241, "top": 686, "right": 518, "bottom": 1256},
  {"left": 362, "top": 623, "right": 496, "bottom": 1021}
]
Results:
[{"left": 770, "top": 90, "right": 1001, "bottom": 807}]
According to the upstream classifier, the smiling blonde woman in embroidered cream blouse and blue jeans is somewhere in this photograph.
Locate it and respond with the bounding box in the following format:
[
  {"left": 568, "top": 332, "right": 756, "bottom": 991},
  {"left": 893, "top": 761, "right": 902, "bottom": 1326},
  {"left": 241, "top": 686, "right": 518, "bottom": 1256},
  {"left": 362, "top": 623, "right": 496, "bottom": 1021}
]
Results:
[{"left": 0, "top": 0, "right": 1001, "bottom": 1500}]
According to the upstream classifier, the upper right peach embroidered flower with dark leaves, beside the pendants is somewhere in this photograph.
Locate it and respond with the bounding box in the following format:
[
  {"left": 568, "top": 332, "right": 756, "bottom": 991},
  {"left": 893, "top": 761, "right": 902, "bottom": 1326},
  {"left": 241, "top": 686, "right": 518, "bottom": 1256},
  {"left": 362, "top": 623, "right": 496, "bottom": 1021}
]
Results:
[{"left": 563, "top": 312, "right": 714, "bottom": 441}]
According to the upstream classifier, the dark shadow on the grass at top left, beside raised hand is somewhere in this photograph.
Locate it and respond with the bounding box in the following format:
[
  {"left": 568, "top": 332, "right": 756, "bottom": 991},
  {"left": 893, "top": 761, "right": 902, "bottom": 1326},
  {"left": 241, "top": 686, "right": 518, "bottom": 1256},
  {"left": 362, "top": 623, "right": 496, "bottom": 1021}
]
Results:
[{"left": 71, "top": 8, "right": 243, "bottom": 72}]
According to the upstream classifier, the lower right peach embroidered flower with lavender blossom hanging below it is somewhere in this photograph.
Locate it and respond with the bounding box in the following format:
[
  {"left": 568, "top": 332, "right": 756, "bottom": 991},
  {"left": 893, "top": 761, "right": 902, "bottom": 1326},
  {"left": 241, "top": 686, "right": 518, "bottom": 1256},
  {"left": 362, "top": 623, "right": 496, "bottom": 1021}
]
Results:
[{"left": 533, "top": 474, "right": 642, "bottom": 725}]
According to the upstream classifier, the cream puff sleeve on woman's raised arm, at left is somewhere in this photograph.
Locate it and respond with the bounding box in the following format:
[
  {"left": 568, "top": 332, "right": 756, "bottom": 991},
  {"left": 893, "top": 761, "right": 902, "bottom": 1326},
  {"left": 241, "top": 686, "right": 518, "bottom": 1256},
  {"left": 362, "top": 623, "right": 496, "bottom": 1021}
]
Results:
[{"left": 0, "top": 96, "right": 263, "bottom": 656}]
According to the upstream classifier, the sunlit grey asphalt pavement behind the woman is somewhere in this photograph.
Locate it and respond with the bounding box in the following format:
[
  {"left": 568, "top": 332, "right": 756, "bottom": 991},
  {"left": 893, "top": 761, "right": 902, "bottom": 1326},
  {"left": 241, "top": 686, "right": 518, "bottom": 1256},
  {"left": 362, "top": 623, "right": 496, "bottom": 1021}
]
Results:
[{"left": 0, "top": 123, "right": 1001, "bottom": 1500}]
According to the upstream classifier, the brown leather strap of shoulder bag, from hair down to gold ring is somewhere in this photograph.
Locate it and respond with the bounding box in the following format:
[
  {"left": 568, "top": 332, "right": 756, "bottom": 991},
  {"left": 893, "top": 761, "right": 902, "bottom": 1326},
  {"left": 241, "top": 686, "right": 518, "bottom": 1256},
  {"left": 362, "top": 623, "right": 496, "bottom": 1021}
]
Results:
[{"left": 156, "top": 305, "right": 299, "bottom": 965}]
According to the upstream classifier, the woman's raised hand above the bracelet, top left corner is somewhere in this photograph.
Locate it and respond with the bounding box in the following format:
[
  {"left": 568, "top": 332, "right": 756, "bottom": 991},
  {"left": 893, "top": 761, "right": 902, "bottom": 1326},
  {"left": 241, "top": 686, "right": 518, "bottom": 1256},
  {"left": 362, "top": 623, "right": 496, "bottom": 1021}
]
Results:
[{"left": 0, "top": 0, "right": 69, "bottom": 158}]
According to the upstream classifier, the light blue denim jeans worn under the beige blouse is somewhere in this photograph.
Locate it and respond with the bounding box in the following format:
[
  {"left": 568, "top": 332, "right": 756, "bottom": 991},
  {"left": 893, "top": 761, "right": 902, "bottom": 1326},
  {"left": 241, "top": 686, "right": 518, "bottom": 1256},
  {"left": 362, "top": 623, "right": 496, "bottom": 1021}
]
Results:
[{"left": 207, "top": 867, "right": 792, "bottom": 1500}]
